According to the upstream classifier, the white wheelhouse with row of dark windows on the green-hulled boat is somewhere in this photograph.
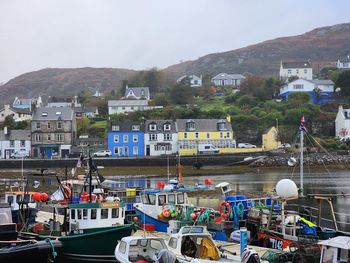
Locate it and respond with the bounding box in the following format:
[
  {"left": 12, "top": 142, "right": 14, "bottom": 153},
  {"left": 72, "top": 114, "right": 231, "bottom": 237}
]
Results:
[{"left": 68, "top": 202, "right": 125, "bottom": 233}]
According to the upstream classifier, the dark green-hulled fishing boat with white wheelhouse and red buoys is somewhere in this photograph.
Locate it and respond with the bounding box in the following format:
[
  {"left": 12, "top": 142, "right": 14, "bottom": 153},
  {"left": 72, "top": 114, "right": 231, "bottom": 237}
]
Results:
[{"left": 39, "top": 157, "right": 135, "bottom": 262}]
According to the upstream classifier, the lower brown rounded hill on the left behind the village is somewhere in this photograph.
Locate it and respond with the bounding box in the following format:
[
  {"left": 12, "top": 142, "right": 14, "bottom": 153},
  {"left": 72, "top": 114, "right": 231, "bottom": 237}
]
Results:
[{"left": 0, "top": 68, "right": 136, "bottom": 105}]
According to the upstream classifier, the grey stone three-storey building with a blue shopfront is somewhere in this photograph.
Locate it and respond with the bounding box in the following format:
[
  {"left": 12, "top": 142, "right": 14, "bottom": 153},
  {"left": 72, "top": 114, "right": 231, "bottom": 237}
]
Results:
[{"left": 31, "top": 107, "right": 77, "bottom": 158}]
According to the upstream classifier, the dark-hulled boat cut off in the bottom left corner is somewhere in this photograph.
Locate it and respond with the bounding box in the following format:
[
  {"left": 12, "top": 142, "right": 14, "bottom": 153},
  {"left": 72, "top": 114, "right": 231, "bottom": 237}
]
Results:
[{"left": 0, "top": 203, "right": 62, "bottom": 263}]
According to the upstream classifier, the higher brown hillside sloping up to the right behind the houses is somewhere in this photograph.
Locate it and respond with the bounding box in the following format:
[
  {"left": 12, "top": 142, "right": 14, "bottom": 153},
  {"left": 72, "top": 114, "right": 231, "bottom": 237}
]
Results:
[{"left": 165, "top": 23, "right": 350, "bottom": 76}]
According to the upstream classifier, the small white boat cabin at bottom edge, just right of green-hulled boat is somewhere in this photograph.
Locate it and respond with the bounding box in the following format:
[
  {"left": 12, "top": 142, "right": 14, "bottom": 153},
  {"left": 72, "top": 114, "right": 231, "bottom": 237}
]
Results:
[{"left": 114, "top": 236, "right": 168, "bottom": 263}]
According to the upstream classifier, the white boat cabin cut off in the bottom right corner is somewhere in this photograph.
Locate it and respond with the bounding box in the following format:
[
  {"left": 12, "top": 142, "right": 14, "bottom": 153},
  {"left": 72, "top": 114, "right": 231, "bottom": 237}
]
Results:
[{"left": 318, "top": 236, "right": 350, "bottom": 263}]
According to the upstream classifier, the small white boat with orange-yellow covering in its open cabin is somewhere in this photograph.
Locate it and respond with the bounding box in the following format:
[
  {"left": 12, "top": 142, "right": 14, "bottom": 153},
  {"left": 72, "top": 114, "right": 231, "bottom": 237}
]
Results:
[{"left": 167, "top": 226, "right": 260, "bottom": 263}]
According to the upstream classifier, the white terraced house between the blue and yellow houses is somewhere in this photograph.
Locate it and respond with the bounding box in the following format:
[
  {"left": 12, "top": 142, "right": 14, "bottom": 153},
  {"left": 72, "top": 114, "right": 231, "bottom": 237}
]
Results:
[{"left": 145, "top": 120, "right": 178, "bottom": 156}]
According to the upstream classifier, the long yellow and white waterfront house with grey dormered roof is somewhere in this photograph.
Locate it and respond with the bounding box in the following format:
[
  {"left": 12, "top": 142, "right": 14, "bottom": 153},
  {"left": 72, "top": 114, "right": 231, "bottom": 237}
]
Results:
[{"left": 176, "top": 117, "right": 236, "bottom": 155}]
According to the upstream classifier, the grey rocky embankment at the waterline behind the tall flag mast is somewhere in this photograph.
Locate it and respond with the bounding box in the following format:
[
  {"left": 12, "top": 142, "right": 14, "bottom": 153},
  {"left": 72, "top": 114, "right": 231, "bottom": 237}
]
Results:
[{"left": 249, "top": 153, "right": 350, "bottom": 167}]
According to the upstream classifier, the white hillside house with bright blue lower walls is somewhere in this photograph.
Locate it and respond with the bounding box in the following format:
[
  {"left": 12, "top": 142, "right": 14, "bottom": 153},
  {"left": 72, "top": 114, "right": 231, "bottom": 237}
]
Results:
[{"left": 280, "top": 79, "right": 334, "bottom": 104}]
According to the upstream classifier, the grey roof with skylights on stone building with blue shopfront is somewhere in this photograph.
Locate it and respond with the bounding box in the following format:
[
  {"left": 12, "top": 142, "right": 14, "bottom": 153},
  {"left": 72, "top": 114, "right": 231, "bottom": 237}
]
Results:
[{"left": 32, "top": 107, "right": 74, "bottom": 121}]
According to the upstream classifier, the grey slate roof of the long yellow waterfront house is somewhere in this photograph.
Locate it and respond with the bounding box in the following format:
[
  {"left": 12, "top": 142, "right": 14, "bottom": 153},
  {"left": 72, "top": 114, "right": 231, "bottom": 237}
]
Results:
[{"left": 176, "top": 119, "right": 232, "bottom": 132}]
